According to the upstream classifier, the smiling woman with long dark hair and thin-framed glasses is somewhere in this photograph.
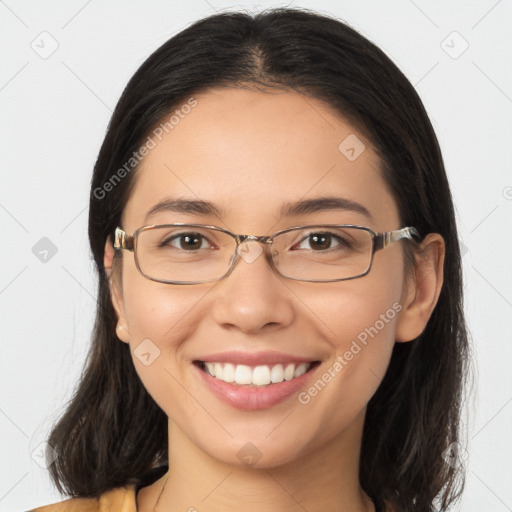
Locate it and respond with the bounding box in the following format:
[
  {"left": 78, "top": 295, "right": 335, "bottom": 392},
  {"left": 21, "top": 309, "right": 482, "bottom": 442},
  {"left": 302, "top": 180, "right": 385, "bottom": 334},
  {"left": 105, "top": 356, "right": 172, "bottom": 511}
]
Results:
[{"left": 28, "top": 8, "right": 467, "bottom": 512}]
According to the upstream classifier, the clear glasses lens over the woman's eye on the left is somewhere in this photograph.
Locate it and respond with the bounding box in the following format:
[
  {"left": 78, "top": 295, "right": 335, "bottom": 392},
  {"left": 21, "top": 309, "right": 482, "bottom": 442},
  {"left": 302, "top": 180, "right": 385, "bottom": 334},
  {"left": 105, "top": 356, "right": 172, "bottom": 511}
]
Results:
[{"left": 137, "top": 226, "right": 236, "bottom": 282}]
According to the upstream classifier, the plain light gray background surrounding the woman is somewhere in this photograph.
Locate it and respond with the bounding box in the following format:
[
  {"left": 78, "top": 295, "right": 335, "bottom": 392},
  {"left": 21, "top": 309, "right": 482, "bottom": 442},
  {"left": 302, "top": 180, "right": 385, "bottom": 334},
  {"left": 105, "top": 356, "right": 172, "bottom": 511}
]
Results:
[{"left": 0, "top": 0, "right": 512, "bottom": 512}]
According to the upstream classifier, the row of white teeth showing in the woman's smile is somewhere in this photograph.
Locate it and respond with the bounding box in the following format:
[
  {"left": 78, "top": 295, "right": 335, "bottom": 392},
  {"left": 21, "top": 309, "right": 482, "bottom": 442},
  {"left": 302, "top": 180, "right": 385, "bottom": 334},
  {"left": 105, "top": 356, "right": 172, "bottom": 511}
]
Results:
[{"left": 194, "top": 361, "right": 320, "bottom": 387}]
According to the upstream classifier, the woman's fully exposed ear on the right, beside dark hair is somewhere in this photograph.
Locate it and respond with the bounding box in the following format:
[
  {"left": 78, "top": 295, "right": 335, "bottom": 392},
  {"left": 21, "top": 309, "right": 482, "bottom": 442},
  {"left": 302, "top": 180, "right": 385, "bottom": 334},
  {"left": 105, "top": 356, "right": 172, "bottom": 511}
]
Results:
[{"left": 395, "top": 233, "right": 445, "bottom": 342}]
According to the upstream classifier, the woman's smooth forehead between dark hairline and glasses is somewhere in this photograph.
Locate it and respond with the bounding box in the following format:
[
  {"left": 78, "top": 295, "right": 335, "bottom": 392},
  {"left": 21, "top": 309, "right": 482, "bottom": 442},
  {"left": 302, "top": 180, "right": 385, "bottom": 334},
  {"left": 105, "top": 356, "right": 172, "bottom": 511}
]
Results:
[{"left": 123, "top": 88, "right": 398, "bottom": 229}]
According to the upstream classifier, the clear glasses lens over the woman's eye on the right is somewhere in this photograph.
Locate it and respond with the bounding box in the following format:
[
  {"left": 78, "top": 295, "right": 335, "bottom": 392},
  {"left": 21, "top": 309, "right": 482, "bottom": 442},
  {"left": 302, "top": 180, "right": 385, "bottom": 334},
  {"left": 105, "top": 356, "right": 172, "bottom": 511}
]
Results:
[{"left": 272, "top": 225, "right": 373, "bottom": 281}]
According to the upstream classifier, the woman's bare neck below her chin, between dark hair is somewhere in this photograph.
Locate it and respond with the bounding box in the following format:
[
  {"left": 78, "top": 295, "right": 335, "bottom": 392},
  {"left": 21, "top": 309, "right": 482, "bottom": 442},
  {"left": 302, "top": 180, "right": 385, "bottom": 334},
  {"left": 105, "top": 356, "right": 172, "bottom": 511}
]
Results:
[{"left": 147, "top": 410, "right": 374, "bottom": 512}]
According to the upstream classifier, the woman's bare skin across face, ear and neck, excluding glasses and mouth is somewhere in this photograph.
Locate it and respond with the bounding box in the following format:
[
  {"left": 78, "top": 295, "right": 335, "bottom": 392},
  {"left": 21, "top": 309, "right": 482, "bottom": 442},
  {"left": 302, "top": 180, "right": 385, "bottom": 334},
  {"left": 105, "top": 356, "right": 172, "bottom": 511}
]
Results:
[{"left": 105, "top": 88, "right": 445, "bottom": 512}]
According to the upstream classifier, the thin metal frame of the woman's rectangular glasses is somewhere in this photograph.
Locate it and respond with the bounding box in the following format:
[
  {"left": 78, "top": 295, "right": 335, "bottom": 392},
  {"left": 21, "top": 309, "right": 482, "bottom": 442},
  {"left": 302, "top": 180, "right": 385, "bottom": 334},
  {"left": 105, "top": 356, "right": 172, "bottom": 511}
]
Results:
[{"left": 114, "top": 223, "right": 421, "bottom": 284}]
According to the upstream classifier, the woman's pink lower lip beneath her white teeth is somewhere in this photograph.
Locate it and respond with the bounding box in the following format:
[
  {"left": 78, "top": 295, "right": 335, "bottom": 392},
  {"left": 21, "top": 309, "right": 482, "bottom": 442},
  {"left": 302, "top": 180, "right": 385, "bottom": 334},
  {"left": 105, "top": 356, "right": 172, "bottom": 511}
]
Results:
[{"left": 192, "top": 364, "right": 319, "bottom": 411}]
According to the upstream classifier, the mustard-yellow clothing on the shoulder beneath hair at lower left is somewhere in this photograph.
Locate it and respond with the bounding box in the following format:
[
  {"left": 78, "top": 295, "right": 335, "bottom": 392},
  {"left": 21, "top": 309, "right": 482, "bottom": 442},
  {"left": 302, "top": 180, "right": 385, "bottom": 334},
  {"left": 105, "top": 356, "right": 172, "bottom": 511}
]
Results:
[{"left": 28, "top": 484, "right": 137, "bottom": 512}]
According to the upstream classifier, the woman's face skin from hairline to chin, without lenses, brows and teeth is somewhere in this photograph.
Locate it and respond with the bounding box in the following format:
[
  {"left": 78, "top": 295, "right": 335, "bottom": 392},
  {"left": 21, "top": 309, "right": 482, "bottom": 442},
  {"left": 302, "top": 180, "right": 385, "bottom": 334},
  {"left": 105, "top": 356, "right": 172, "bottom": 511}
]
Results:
[{"left": 109, "top": 89, "right": 416, "bottom": 467}]
